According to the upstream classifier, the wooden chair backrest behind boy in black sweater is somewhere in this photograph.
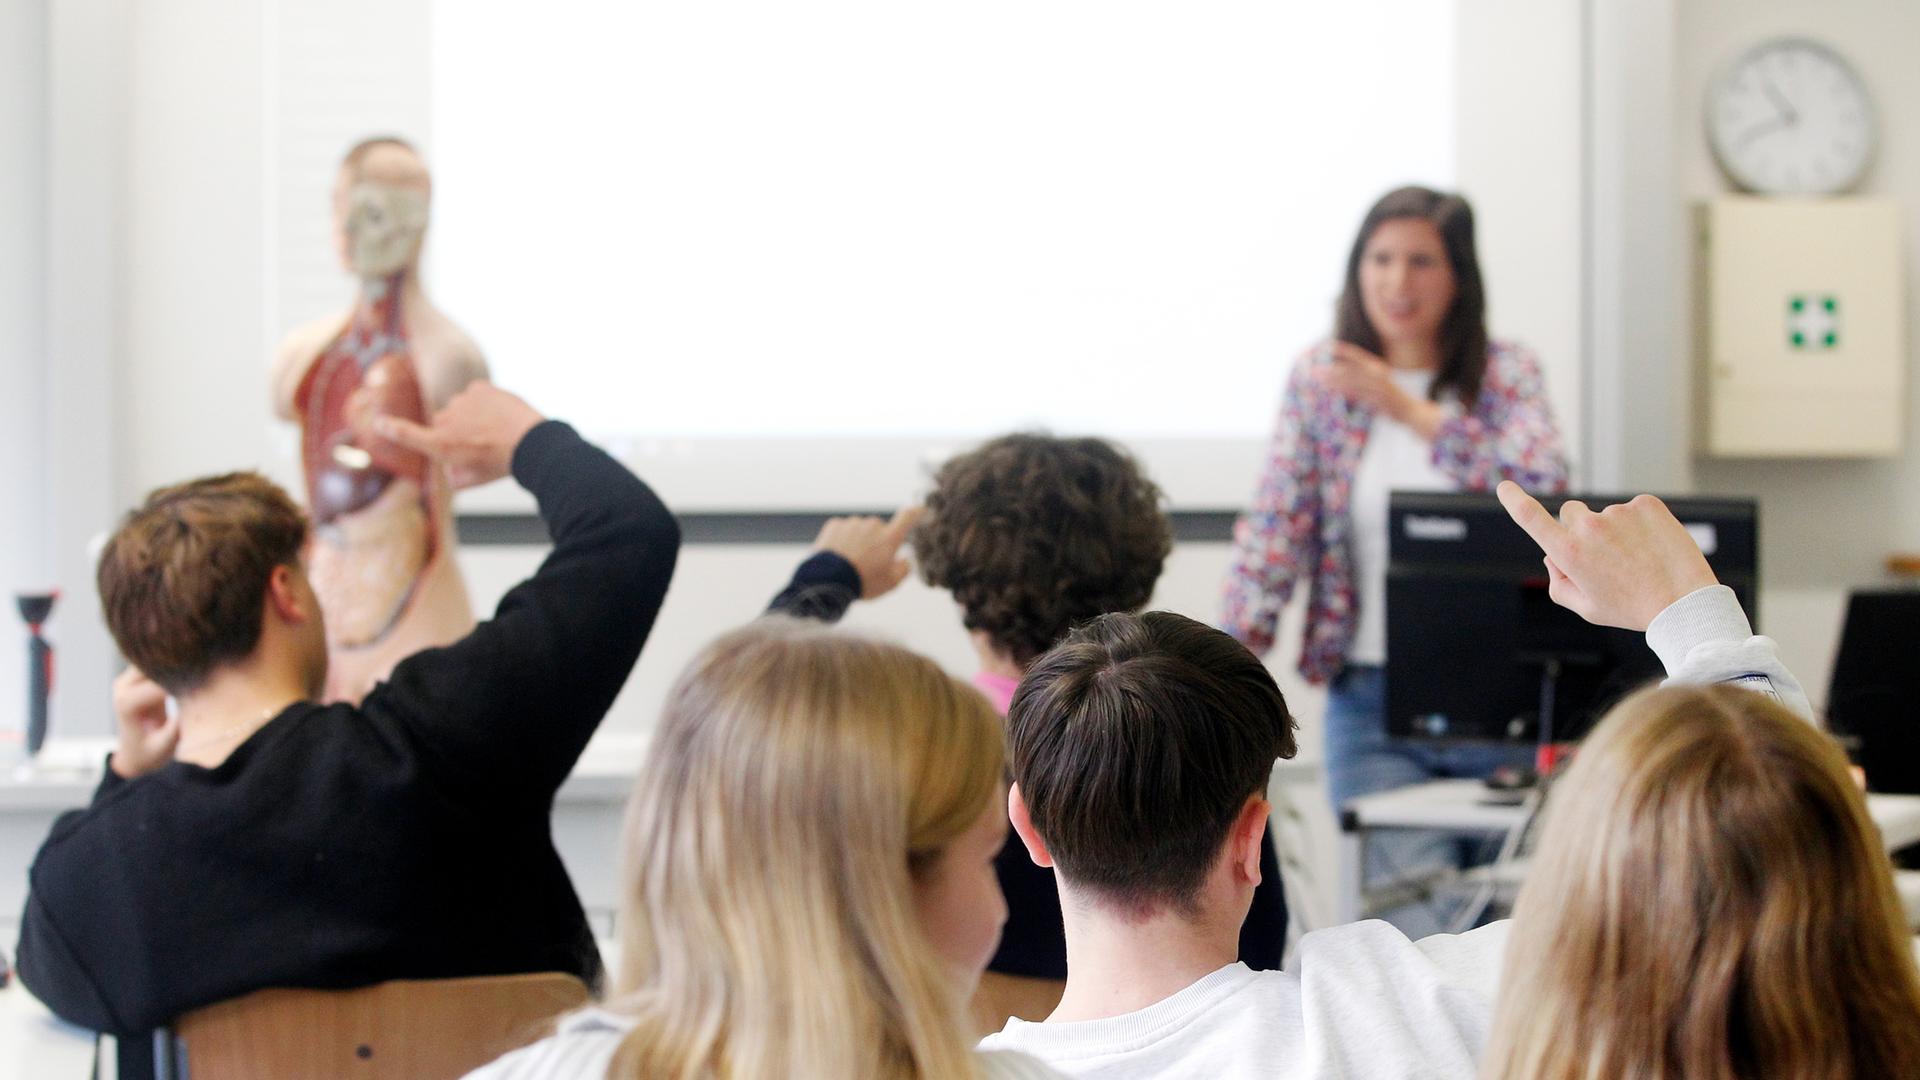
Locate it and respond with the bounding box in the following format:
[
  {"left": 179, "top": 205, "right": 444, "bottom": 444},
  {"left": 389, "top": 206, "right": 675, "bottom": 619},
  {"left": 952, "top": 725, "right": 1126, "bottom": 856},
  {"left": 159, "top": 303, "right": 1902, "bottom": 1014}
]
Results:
[{"left": 173, "top": 972, "right": 589, "bottom": 1080}]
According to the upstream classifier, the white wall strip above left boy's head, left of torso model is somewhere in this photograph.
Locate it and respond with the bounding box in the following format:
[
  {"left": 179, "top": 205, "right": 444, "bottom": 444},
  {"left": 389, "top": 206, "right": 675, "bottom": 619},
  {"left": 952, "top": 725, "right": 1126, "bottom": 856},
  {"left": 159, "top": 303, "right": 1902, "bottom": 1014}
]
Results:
[{"left": 115, "top": 0, "right": 269, "bottom": 503}]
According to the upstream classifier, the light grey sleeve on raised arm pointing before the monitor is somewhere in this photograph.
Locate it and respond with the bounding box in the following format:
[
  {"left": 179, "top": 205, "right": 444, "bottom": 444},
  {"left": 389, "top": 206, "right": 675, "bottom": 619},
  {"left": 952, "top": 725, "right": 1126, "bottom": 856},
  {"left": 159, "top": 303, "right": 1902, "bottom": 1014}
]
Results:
[{"left": 1647, "top": 584, "right": 1814, "bottom": 721}]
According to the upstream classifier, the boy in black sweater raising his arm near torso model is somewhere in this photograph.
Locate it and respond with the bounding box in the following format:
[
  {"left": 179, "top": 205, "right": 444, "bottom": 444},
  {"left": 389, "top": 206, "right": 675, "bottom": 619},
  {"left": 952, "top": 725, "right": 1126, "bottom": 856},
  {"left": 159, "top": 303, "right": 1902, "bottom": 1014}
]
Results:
[{"left": 19, "top": 382, "right": 680, "bottom": 1074}]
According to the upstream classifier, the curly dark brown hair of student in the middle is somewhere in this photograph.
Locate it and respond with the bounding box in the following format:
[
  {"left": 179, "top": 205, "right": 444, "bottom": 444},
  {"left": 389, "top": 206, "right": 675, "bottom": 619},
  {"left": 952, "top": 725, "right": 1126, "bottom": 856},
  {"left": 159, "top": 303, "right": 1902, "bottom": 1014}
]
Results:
[{"left": 914, "top": 434, "right": 1173, "bottom": 667}]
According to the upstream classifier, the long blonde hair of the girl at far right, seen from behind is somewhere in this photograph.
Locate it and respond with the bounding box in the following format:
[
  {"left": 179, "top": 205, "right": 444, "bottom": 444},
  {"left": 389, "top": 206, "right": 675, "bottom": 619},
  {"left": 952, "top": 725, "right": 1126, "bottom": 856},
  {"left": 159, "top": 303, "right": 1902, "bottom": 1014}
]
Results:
[{"left": 1486, "top": 686, "right": 1920, "bottom": 1080}]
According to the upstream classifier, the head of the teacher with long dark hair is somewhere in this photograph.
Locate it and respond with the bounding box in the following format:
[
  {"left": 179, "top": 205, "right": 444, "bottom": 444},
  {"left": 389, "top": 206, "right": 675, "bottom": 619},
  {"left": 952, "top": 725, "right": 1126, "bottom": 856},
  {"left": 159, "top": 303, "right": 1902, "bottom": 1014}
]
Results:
[{"left": 1334, "top": 186, "right": 1486, "bottom": 405}]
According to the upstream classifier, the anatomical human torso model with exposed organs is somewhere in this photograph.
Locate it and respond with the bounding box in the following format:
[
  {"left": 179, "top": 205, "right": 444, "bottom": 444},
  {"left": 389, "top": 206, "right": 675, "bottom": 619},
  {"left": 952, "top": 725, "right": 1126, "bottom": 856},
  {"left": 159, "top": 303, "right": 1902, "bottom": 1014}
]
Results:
[{"left": 275, "top": 140, "right": 486, "bottom": 701}]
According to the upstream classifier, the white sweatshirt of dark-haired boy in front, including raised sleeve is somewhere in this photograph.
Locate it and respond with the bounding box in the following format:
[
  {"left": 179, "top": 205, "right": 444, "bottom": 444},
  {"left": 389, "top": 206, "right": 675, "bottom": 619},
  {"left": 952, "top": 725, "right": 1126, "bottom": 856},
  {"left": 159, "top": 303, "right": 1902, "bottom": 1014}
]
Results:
[{"left": 981, "top": 586, "right": 1812, "bottom": 1080}]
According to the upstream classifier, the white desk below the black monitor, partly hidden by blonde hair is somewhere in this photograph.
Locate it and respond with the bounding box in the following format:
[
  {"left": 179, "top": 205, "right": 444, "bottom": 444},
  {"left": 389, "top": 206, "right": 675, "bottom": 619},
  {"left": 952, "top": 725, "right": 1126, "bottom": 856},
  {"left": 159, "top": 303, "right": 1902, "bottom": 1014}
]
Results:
[{"left": 1334, "top": 780, "right": 1920, "bottom": 922}]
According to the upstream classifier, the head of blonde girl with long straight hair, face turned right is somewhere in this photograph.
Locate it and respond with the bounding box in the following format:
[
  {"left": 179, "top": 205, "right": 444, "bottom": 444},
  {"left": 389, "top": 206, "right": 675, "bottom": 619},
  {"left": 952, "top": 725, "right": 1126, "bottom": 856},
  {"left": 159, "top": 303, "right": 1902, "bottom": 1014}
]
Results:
[{"left": 611, "top": 617, "right": 1006, "bottom": 1078}]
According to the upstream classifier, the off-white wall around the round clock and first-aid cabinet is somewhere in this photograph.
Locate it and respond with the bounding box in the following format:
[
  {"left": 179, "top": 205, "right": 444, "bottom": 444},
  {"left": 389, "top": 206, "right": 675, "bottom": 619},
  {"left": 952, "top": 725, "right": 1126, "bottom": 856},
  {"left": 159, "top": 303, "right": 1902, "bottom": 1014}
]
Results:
[{"left": 1663, "top": 0, "right": 1920, "bottom": 703}]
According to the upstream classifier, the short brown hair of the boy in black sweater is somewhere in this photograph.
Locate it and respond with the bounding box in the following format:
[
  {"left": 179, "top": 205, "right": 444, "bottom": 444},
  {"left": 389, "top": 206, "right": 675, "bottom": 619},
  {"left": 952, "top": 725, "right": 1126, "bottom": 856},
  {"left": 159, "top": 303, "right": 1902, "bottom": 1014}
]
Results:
[{"left": 96, "top": 473, "right": 307, "bottom": 696}]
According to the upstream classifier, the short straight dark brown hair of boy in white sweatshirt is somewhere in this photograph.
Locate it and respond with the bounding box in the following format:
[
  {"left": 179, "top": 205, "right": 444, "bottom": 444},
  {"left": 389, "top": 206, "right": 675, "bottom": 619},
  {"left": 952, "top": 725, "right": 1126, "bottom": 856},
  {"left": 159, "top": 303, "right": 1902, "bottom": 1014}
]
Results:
[{"left": 1006, "top": 611, "right": 1296, "bottom": 915}]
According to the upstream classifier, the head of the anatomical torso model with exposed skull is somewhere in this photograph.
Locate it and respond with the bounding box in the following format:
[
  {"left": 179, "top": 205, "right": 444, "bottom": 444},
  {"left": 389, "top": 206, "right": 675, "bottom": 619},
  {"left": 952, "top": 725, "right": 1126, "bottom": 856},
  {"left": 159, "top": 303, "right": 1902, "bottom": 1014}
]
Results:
[{"left": 334, "top": 135, "right": 434, "bottom": 279}]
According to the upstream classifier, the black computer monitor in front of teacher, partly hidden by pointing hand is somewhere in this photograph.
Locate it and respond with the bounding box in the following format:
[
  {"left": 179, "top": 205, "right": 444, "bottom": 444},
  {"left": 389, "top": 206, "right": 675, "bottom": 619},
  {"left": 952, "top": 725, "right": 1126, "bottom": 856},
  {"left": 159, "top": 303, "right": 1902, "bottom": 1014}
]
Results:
[{"left": 1386, "top": 492, "right": 1759, "bottom": 744}]
